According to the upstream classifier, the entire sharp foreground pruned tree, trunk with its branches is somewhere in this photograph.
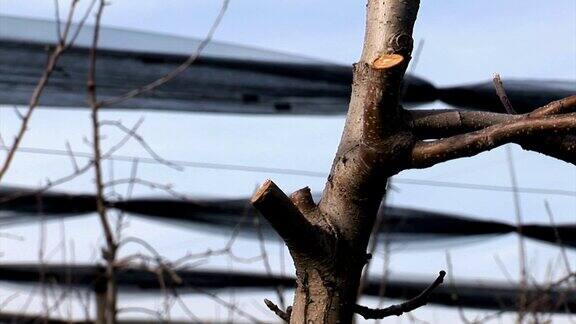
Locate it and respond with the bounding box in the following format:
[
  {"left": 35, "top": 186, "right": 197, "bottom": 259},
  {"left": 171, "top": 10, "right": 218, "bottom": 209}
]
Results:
[{"left": 252, "top": 0, "right": 576, "bottom": 323}]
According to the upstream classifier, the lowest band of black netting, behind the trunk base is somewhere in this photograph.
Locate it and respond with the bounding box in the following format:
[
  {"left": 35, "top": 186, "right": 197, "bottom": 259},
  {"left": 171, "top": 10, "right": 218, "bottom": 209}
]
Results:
[{"left": 0, "top": 264, "right": 576, "bottom": 313}]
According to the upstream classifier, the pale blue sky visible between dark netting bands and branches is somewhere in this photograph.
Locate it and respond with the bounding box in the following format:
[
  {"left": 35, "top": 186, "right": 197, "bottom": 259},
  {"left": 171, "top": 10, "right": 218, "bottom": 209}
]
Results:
[{"left": 0, "top": 0, "right": 576, "bottom": 323}]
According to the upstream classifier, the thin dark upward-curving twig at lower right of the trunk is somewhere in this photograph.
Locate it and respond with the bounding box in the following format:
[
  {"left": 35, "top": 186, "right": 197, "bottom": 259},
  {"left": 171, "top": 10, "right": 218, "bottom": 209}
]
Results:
[{"left": 354, "top": 271, "right": 446, "bottom": 319}]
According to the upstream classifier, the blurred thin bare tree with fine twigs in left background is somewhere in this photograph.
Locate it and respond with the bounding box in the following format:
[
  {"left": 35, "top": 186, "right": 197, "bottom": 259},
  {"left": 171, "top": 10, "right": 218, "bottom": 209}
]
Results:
[{"left": 0, "top": 0, "right": 237, "bottom": 324}]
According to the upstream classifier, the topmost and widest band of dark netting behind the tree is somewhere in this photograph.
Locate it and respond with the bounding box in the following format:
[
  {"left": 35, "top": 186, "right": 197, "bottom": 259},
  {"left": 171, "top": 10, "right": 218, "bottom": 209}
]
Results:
[{"left": 0, "top": 16, "right": 576, "bottom": 115}]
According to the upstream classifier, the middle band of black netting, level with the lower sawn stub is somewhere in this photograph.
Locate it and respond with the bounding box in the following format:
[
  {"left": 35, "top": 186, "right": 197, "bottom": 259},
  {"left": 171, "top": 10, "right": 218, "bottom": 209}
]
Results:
[{"left": 0, "top": 187, "right": 576, "bottom": 248}]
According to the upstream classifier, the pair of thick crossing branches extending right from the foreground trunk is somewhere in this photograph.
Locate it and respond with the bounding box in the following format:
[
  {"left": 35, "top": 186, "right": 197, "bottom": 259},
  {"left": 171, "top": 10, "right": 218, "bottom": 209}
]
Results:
[{"left": 411, "top": 96, "right": 576, "bottom": 168}]
